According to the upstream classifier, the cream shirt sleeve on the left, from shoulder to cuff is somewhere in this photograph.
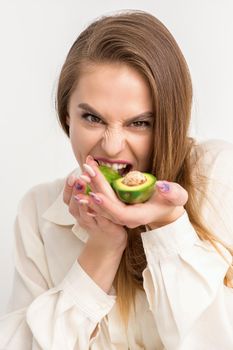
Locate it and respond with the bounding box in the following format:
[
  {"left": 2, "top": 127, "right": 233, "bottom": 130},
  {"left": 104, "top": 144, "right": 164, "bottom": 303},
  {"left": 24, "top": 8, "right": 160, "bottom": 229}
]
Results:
[{"left": 0, "top": 189, "right": 115, "bottom": 350}]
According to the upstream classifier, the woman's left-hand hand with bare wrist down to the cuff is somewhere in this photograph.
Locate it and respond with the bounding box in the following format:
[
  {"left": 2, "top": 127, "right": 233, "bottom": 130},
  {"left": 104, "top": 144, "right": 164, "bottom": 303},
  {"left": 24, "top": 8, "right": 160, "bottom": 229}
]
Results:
[{"left": 63, "top": 168, "right": 127, "bottom": 293}]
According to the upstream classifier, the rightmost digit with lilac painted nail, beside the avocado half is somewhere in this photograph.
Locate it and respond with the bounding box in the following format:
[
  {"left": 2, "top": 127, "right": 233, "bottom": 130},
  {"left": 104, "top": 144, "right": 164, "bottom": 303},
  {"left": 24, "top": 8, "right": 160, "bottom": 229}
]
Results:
[{"left": 156, "top": 181, "right": 188, "bottom": 206}]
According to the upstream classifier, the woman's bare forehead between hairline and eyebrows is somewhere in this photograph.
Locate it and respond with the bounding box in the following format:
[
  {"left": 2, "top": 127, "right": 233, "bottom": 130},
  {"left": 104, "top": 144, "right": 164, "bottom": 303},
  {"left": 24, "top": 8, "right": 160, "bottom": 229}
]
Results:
[{"left": 70, "top": 64, "right": 152, "bottom": 115}]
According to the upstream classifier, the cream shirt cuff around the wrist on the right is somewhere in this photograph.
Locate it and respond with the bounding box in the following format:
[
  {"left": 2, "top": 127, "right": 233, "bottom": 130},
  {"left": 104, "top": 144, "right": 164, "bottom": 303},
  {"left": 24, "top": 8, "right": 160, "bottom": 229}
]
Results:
[{"left": 141, "top": 211, "right": 199, "bottom": 256}]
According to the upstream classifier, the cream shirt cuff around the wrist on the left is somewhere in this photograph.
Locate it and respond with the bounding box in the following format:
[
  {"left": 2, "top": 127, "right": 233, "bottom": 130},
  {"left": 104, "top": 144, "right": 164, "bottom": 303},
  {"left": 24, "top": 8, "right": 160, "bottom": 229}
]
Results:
[{"left": 59, "top": 261, "right": 116, "bottom": 323}]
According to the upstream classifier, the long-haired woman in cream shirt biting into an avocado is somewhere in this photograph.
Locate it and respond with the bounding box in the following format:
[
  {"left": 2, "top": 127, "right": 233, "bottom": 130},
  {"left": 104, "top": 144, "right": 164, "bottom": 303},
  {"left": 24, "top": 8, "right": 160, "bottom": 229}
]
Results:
[{"left": 0, "top": 11, "right": 233, "bottom": 350}]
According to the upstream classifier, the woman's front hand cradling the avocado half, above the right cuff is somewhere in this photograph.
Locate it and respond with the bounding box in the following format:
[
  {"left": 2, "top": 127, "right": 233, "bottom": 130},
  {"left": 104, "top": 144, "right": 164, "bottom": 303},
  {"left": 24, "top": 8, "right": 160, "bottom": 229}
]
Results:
[{"left": 80, "top": 157, "right": 188, "bottom": 229}]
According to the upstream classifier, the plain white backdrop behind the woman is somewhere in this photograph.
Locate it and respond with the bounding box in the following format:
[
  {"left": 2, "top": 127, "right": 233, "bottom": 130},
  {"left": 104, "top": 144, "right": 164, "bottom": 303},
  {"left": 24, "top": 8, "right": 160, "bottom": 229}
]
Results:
[{"left": 0, "top": 0, "right": 233, "bottom": 313}]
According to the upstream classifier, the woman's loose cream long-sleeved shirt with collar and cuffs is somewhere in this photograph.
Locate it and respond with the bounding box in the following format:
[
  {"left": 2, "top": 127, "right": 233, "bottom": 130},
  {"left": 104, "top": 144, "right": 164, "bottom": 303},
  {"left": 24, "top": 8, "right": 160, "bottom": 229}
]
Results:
[{"left": 0, "top": 141, "right": 233, "bottom": 350}]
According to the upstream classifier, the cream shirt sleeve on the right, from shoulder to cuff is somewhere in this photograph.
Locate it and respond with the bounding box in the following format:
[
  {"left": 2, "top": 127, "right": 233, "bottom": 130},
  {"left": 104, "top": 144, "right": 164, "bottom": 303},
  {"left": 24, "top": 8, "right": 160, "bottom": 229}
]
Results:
[{"left": 142, "top": 141, "right": 233, "bottom": 350}]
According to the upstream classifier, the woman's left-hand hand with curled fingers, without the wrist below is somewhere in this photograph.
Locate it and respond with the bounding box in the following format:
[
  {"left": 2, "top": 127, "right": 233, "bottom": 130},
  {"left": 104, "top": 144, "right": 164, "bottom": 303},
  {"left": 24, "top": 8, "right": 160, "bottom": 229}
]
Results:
[{"left": 63, "top": 173, "right": 127, "bottom": 252}]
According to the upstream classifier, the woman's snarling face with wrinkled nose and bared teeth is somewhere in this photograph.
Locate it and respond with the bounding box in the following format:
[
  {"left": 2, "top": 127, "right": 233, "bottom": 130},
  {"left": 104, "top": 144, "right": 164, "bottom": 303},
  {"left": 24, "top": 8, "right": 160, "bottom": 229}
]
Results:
[{"left": 67, "top": 64, "right": 154, "bottom": 174}]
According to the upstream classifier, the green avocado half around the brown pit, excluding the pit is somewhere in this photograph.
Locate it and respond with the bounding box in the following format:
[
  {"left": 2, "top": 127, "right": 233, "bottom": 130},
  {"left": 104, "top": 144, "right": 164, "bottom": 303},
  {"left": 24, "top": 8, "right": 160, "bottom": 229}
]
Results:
[{"left": 112, "top": 173, "right": 156, "bottom": 204}]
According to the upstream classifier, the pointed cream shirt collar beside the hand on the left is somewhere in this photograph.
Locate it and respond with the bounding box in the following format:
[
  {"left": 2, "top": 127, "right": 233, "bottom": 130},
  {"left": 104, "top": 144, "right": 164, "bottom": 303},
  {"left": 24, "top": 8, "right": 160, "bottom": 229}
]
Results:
[{"left": 42, "top": 175, "right": 88, "bottom": 242}]
